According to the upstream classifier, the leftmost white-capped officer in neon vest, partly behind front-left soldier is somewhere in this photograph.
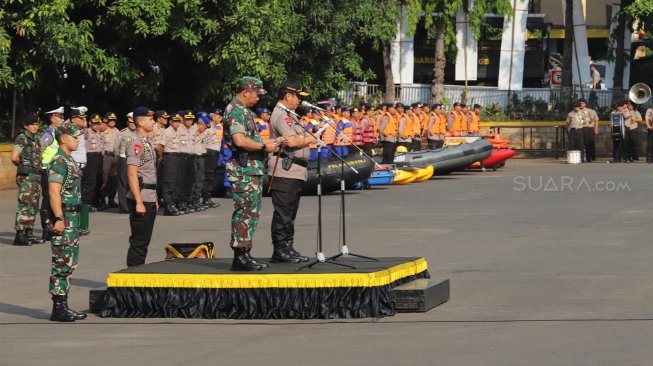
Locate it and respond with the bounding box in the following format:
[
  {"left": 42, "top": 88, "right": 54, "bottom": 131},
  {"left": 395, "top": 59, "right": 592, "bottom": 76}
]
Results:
[{"left": 39, "top": 107, "right": 64, "bottom": 241}]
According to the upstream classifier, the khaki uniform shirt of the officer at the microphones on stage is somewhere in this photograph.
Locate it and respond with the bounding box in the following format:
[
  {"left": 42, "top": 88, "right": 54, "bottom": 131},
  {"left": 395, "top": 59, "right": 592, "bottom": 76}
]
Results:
[{"left": 270, "top": 106, "right": 311, "bottom": 180}]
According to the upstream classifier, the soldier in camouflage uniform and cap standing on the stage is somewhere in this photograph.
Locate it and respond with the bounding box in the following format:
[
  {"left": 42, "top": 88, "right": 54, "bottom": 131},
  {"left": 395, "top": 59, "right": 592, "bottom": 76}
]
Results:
[{"left": 224, "top": 76, "right": 281, "bottom": 271}]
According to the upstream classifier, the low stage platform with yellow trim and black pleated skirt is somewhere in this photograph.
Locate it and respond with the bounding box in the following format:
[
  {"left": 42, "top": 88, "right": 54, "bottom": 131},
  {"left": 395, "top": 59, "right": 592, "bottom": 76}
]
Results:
[{"left": 97, "top": 257, "right": 429, "bottom": 319}]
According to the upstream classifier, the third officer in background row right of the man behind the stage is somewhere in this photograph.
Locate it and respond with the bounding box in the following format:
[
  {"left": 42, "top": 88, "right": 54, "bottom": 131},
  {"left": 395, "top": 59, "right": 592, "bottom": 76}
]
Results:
[{"left": 175, "top": 110, "right": 196, "bottom": 213}]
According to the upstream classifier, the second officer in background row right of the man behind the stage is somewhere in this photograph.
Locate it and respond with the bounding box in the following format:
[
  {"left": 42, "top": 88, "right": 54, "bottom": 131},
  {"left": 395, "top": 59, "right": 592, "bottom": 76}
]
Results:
[{"left": 157, "top": 113, "right": 187, "bottom": 216}]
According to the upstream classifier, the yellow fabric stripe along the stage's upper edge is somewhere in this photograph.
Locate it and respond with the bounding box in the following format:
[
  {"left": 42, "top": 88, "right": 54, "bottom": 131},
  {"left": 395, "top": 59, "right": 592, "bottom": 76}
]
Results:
[{"left": 107, "top": 258, "right": 428, "bottom": 289}]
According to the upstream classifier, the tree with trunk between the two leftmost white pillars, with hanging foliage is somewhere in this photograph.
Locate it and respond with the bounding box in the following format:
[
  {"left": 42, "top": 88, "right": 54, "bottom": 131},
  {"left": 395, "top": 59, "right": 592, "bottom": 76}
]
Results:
[{"left": 407, "top": 0, "right": 512, "bottom": 103}]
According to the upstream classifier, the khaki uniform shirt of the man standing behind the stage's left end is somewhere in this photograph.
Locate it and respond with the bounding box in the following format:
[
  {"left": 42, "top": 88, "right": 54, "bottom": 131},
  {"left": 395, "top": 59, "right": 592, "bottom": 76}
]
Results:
[{"left": 125, "top": 131, "right": 157, "bottom": 202}]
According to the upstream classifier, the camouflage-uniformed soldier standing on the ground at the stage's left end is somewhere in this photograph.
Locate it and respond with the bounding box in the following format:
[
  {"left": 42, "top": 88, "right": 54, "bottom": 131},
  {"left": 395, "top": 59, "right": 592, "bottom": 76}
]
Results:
[{"left": 48, "top": 123, "right": 86, "bottom": 322}]
